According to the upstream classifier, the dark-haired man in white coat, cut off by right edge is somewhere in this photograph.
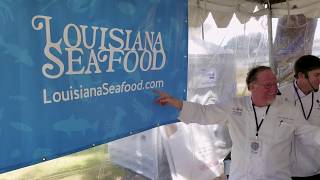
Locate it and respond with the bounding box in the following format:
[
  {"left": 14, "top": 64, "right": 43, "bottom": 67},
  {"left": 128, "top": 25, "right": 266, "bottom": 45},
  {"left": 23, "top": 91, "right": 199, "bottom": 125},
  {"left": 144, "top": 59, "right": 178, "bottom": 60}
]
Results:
[{"left": 280, "top": 55, "right": 320, "bottom": 180}]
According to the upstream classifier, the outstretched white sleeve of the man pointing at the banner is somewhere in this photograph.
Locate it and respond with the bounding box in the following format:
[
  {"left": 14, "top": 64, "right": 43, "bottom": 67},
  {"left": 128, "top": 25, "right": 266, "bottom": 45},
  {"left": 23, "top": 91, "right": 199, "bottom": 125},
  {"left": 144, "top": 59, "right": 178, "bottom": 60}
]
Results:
[{"left": 178, "top": 101, "right": 231, "bottom": 125}]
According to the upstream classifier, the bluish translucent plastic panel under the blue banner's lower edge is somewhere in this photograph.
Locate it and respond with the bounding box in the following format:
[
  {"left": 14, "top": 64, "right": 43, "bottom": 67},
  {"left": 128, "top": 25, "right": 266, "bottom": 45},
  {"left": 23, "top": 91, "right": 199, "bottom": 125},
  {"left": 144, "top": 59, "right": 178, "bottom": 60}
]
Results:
[{"left": 108, "top": 128, "right": 170, "bottom": 180}]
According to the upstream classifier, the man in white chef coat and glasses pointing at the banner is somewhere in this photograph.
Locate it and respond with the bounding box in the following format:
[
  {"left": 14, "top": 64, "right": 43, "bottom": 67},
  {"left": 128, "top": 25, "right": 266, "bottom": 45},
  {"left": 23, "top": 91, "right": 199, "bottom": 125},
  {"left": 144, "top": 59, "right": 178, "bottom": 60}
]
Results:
[{"left": 156, "top": 66, "right": 320, "bottom": 180}]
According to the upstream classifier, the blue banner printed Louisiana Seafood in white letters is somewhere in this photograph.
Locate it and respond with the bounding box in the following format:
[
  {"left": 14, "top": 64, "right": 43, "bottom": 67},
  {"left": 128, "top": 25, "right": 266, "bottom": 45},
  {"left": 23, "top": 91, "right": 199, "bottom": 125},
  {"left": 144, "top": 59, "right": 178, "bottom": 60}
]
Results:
[{"left": 0, "top": 0, "right": 188, "bottom": 173}]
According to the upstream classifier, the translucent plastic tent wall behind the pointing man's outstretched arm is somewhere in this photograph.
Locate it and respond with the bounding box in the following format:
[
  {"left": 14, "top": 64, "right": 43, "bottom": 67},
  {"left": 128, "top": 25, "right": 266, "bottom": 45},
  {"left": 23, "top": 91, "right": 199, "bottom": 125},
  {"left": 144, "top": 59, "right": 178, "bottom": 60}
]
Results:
[{"left": 109, "top": 14, "right": 269, "bottom": 180}]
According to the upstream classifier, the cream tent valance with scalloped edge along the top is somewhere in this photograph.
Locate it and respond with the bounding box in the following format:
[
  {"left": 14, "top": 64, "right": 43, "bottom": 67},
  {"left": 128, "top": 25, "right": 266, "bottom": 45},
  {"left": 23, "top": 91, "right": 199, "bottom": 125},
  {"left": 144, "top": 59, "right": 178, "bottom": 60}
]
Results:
[{"left": 189, "top": 0, "right": 320, "bottom": 28}]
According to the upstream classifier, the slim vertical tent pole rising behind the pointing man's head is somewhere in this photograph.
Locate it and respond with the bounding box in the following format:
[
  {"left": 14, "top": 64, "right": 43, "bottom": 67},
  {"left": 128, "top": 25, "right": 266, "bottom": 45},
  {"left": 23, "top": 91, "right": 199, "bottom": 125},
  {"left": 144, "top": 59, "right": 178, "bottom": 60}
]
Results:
[{"left": 267, "top": 0, "right": 278, "bottom": 75}]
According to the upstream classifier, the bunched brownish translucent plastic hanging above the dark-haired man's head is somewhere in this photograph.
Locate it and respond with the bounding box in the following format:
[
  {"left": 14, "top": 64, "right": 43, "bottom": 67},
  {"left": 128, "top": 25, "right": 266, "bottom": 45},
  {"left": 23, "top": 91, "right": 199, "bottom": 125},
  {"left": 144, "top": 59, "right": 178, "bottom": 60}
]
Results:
[{"left": 273, "top": 15, "right": 320, "bottom": 84}]
